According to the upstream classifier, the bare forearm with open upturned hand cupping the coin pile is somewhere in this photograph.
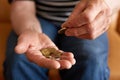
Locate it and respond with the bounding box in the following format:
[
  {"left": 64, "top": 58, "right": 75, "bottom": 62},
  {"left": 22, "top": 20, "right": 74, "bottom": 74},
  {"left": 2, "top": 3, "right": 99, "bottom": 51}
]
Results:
[{"left": 11, "top": 0, "right": 75, "bottom": 69}]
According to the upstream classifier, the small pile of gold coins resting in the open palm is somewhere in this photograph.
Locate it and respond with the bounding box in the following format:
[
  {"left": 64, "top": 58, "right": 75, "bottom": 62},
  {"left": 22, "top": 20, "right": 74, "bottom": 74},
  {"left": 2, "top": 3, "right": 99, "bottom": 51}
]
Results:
[{"left": 40, "top": 47, "right": 63, "bottom": 60}]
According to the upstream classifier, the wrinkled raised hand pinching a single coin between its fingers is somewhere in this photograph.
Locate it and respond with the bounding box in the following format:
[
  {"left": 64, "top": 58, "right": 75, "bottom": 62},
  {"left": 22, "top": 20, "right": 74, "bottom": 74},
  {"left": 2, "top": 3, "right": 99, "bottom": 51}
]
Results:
[{"left": 62, "top": 0, "right": 112, "bottom": 39}]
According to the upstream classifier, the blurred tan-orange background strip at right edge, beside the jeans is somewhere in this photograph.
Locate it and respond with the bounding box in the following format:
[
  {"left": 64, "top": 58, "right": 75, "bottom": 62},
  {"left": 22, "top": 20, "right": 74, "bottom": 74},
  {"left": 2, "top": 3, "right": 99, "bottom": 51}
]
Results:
[{"left": 108, "top": 14, "right": 120, "bottom": 80}]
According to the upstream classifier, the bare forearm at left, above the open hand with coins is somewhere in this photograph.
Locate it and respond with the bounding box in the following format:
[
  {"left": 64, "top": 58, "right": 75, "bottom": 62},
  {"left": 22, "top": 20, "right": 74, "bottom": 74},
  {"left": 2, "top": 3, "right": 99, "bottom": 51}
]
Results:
[{"left": 11, "top": 1, "right": 41, "bottom": 35}]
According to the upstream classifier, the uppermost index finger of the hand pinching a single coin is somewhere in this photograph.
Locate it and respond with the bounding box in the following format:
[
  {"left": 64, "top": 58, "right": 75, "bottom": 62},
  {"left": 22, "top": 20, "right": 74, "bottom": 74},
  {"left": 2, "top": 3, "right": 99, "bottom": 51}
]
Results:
[{"left": 62, "top": 2, "right": 101, "bottom": 28}]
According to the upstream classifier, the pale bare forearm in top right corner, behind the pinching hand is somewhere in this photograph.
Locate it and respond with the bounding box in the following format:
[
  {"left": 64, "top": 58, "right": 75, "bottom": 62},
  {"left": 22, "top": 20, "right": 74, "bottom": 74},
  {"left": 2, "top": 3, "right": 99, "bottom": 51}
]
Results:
[{"left": 105, "top": 0, "right": 120, "bottom": 14}]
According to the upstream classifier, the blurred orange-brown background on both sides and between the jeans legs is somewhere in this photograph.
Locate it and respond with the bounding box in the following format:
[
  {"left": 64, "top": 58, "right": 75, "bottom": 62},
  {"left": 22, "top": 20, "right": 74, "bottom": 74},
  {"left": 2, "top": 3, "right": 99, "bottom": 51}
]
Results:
[{"left": 0, "top": 0, "right": 120, "bottom": 80}]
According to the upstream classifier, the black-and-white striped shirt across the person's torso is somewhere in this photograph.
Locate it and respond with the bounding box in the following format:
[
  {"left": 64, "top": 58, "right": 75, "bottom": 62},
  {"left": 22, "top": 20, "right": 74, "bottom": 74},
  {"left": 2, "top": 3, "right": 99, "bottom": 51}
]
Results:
[{"left": 8, "top": 0, "right": 79, "bottom": 24}]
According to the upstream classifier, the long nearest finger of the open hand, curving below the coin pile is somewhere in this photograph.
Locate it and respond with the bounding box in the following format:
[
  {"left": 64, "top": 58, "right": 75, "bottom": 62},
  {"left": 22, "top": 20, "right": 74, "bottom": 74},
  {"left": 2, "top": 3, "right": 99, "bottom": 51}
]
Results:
[{"left": 26, "top": 50, "right": 60, "bottom": 69}]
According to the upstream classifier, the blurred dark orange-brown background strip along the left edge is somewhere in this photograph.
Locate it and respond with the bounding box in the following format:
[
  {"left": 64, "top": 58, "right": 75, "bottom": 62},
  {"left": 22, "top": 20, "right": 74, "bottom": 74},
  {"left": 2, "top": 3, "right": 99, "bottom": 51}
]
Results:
[{"left": 0, "top": 0, "right": 11, "bottom": 80}]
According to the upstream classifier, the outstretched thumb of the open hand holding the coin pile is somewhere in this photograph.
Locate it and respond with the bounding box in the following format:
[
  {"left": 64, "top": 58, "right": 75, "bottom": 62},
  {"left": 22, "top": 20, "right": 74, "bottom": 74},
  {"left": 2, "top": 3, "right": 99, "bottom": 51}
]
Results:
[{"left": 15, "top": 39, "right": 29, "bottom": 54}]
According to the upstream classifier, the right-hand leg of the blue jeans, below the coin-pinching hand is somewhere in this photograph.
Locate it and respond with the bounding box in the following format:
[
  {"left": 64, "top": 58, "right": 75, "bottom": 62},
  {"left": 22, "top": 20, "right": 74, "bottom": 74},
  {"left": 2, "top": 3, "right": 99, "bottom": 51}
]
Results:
[{"left": 60, "top": 33, "right": 109, "bottom": 80}]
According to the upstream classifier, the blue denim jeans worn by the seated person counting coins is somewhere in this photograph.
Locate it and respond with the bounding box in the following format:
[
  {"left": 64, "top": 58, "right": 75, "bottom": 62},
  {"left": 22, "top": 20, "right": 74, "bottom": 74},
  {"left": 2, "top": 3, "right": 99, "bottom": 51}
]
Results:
[{"left": 4, "top": 18, "right": 109, "bottom": 80}]
